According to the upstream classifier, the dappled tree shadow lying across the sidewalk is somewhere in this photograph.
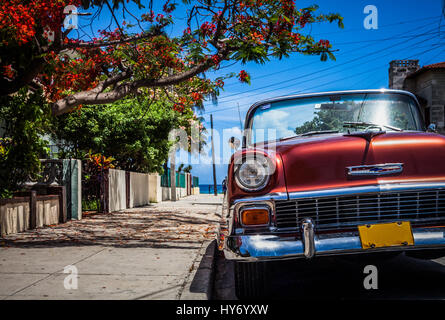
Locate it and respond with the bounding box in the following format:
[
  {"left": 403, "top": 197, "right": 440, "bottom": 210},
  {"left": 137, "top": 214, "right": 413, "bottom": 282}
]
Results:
[{"left": 0, "top": 206, "right": 216, "bottom": 249}]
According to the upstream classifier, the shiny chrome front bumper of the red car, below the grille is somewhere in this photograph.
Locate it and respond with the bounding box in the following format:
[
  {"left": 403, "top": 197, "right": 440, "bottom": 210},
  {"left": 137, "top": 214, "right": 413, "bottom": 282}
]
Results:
[{"left": 221, "top": 221, "right": 445, "bottom": 261}]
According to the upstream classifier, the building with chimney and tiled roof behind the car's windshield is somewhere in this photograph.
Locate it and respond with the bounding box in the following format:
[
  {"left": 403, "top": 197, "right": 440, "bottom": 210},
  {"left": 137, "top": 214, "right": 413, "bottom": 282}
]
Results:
[{"left": 389, "top": 60, "right": 445, "bottom": 134}]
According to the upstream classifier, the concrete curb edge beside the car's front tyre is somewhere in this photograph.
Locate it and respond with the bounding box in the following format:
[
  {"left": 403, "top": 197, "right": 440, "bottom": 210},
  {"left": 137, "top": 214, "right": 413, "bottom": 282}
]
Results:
[{"left": 179, "top": 240, "right": 216, "bottom": 300}]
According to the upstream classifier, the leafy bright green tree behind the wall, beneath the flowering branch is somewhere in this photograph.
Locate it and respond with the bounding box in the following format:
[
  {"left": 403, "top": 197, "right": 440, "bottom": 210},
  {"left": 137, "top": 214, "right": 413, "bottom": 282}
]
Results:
[{"left": 50, "top": 97, "right": 193, "bottom": 172}]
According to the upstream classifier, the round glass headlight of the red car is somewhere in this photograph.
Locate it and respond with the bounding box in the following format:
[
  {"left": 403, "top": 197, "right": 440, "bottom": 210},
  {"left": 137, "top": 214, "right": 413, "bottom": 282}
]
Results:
[{"left": 235, "top": 157, "right": 271, "bottom": 191}]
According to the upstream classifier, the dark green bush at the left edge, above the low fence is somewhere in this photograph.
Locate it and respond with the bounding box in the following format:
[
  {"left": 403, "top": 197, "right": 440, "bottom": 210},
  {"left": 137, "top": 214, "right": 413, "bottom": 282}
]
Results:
[{"left": 0, "top": 88, "right": 51, "bottom": 198}]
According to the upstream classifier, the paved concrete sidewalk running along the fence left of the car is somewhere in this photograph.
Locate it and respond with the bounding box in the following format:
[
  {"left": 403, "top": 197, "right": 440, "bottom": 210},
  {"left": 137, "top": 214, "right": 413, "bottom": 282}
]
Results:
[{"left": 0, "top": 195, "right": 222, "bottom": 299}]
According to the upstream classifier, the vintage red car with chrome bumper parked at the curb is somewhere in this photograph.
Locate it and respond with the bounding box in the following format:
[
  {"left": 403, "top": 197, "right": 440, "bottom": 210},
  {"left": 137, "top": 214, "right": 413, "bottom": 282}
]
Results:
[{"left": 219, "top": 90, "right": 445, "bottom": 297}]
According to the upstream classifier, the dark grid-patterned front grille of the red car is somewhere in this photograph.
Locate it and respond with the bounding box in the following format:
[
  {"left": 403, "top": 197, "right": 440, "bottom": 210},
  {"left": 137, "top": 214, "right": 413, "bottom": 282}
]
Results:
[{"left": 275, "top": 189, "right": 445, "bottom": 231}]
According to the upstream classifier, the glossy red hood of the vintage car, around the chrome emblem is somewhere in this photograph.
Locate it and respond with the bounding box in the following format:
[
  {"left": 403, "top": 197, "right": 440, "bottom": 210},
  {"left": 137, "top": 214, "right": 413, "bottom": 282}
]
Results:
[{"left": 269, "top": 132, "right": 445, "bottom": 193}]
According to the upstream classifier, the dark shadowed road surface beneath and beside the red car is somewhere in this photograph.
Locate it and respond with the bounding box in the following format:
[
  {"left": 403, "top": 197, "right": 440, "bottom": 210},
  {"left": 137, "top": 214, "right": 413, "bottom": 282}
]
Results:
[{"left": 213, "top": 250, "right": 445, "bottom": 300}]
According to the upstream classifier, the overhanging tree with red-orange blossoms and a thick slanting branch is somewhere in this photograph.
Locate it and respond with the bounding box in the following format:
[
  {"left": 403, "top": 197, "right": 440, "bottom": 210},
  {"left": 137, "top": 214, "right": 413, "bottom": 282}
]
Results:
[{"left": 0, "top": 0, "right": 342, "bottom": 115}]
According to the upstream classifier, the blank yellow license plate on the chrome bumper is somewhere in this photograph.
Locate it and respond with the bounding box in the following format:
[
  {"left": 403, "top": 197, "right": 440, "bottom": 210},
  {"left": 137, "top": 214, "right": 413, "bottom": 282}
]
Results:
[{"left": 358, "top": 221, "right": 414, "bottom": 249}]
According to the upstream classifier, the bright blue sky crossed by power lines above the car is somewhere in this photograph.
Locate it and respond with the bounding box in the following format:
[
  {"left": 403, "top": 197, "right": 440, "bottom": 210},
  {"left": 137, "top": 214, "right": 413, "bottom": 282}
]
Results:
[{"left": 77, "top": 0, "right": 445, "bottom": 184}]
